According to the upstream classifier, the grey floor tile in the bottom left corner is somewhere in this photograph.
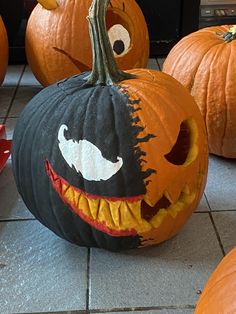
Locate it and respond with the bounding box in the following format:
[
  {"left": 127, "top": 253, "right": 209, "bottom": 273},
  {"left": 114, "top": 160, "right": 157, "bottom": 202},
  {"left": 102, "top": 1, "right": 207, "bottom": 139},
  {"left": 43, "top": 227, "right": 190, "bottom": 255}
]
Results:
[{"left": 0, "top": 221, "right": 87, "bottom": 314}]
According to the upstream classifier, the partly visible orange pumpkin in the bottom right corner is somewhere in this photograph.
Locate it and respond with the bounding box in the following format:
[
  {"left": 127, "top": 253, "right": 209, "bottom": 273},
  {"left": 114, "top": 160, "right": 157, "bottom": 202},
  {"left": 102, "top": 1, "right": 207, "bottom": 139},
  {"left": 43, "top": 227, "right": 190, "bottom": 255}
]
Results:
[{"left": 195, "top": 247, "right": 236, "bottom": 314}]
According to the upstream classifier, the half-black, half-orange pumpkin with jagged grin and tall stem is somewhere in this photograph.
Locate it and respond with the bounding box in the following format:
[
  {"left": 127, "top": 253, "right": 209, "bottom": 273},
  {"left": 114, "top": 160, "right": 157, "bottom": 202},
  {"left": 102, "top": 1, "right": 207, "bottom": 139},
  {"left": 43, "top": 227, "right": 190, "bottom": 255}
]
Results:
[{"left": 12, "top": 0, "right": 208, "bottom": 250}]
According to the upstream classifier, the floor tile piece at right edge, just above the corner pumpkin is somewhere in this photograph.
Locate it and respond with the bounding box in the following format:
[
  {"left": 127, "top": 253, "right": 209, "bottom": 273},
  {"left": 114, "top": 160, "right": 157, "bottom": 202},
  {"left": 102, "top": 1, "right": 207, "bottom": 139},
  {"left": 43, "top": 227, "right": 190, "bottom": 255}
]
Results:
[{"left": 212, "top": 211, "right": 236, "bottom": 253}]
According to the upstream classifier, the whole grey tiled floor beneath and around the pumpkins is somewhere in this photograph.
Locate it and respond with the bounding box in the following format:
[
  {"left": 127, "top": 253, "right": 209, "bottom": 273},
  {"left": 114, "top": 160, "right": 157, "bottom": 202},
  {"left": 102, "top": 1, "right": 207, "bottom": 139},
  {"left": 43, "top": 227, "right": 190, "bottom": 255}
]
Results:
[{"left": 0, "top": 59, "right": 236, "bottom": 314}]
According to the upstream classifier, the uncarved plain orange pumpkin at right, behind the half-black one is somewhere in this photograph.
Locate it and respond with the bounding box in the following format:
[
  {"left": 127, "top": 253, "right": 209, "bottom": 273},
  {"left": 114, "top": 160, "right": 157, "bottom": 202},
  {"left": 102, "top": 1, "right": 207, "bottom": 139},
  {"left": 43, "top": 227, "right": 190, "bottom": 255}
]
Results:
[{"left": 163, "top": 25, "right": 236, "bottom": 158}]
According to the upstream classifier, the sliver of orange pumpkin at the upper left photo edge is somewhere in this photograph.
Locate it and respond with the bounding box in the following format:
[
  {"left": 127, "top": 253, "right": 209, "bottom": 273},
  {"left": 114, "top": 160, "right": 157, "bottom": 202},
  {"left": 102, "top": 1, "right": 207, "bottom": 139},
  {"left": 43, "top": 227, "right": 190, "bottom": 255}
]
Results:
[{"left": 0, "top": 16, "right": 8, "bottom": 85}]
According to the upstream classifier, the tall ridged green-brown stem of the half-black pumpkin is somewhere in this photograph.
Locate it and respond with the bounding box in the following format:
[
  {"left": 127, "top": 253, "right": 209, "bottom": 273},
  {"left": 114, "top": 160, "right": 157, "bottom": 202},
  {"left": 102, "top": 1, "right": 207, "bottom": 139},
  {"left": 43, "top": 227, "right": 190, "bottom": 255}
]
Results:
[{"left": 85, "top": 0, "right": 135, "bottom": 85}]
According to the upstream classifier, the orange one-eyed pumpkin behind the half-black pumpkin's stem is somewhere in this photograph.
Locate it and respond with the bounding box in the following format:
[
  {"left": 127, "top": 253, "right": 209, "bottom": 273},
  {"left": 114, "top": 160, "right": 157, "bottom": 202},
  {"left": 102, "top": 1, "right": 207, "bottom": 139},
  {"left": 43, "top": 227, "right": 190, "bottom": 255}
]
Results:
[{"left": 26, "top": 0, "right": 149, "bottom": 86}]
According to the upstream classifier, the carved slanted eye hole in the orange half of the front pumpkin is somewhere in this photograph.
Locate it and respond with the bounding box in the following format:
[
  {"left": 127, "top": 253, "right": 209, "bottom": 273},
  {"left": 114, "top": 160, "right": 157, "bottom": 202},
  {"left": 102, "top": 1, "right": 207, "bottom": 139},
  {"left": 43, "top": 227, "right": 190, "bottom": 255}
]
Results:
[{"left": 165, "top": 119, "right": 197, "bottom": 165}]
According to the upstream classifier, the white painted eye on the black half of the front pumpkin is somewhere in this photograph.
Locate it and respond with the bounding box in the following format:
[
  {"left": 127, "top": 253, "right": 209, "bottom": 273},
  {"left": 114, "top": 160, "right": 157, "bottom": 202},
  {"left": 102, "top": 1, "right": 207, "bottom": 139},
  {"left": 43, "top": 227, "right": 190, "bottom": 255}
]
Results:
[{"left": 58, "top": 124, "right": 123, "bottom": 181}]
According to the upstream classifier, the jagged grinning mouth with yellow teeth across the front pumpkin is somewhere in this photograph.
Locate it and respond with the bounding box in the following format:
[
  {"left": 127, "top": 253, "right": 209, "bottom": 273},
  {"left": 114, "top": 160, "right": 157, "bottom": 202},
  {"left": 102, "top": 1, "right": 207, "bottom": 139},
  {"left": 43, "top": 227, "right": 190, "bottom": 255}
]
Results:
[{"left": 45, "top": 161, "right": 196, "bottom": 236}]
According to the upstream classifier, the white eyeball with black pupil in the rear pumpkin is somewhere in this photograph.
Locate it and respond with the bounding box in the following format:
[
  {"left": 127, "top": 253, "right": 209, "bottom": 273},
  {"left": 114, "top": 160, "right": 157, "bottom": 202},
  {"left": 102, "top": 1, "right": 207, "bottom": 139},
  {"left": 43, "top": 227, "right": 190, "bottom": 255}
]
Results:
[{"left": 108, "top": 24, "right": 131, "bottom": 56}]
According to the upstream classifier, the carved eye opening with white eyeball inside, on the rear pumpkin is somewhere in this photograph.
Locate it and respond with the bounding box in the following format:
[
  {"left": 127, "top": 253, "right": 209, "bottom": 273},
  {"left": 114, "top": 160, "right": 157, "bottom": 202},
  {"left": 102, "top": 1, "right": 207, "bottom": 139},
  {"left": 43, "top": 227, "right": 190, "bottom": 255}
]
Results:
[{"left": 106, "top": 9, "right": 132, "bottom": 56}]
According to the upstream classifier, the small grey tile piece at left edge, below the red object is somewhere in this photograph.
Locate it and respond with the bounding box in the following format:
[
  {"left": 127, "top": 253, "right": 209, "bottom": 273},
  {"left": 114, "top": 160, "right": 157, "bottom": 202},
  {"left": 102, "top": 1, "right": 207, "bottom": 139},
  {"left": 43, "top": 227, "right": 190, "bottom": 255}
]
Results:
[{"left": 0, "top": 160, "right": 33, "bottom": 220}]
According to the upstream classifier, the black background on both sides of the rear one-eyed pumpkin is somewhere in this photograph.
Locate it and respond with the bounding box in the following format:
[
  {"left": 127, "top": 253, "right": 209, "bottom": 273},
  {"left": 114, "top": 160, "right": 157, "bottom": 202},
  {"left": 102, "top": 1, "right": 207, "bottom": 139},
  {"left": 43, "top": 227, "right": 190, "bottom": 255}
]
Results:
[{"left": 0, "top": 0, "right": 200, "bottom": 63}]
